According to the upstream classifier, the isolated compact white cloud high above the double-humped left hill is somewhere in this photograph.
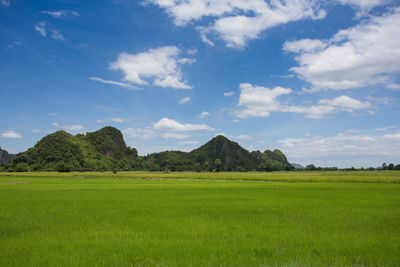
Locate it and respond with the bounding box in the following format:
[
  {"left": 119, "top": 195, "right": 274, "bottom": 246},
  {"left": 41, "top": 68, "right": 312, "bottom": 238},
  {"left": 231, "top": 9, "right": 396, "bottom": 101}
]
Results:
[{"left": 110, "top": 46, "right": 192, "bottom": 89}]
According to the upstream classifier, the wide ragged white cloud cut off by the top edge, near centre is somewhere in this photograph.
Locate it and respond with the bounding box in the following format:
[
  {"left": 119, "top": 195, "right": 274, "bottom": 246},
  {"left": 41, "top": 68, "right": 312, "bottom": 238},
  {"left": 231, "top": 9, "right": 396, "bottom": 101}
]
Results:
[{"left": 146, "top": 0, "right": 325, "bottom": 48}]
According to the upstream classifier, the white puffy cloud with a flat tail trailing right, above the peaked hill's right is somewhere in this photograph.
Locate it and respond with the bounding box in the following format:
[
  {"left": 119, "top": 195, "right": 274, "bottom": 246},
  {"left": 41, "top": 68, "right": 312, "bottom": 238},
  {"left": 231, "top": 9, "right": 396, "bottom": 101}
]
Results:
[{"left": 236, "top": 83, "right": 372, "bottom": 118}]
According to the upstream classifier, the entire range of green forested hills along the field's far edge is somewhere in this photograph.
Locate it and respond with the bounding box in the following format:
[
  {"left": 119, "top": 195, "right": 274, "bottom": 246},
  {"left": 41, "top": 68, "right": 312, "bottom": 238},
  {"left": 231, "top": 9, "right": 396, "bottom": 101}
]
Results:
[{"left": 2, "top": 127, "right": 293, "bottom": 171}]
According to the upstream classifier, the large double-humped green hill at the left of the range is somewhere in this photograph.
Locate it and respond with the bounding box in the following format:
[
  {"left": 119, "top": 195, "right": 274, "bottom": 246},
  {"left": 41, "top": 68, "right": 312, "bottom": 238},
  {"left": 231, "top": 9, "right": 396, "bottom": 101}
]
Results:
[{"left": 8, "top": 127, "right": 138, "bottom": 171}]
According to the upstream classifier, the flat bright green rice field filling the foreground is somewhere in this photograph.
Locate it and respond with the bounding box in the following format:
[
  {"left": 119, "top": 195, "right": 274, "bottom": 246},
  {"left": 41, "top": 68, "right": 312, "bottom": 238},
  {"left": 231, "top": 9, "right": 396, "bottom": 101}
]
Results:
[{"left": 0, "top": 171, "right": 400, "bottom": 266}]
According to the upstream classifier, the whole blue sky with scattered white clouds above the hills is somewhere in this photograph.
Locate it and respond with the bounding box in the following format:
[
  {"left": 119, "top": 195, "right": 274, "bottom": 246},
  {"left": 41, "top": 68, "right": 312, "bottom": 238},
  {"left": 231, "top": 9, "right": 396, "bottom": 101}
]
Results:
[{"left": 0, "top": 0, "right": 400, "bottom": 167}]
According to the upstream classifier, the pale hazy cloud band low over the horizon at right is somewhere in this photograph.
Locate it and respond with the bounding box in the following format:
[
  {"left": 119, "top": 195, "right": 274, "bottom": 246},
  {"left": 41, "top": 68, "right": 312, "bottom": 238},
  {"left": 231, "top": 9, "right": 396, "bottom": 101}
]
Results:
[{"left": 278, "top": 132, "right": 400, "bottom": 167}]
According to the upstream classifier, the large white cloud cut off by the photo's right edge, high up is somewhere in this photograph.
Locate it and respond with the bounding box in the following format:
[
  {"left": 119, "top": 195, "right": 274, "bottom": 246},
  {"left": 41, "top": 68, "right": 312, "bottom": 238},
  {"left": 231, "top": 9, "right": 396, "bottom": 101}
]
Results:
[{"left": 284, "top": 8, "right": 400, "bottom": 91}]
